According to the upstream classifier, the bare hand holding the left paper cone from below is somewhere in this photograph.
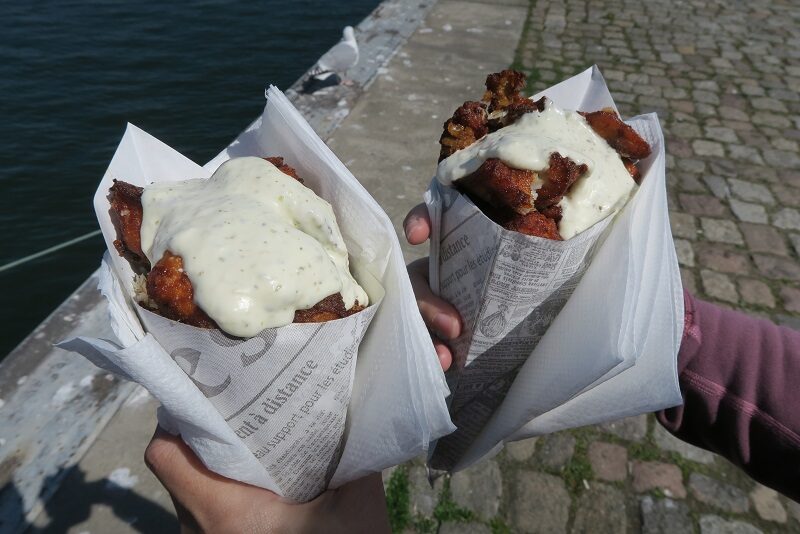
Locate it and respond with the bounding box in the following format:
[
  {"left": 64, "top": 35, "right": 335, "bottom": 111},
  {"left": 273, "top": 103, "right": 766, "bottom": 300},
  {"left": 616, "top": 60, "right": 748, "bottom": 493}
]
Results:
[{"left": 144, "top": 427, "right": 390, "bottom": 533}]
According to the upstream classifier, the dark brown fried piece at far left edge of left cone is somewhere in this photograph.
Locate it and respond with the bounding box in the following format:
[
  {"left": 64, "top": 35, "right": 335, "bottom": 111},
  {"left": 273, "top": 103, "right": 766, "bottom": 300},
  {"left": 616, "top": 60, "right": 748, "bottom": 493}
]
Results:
[{"left": 108, "top": 180, "right": 150, "bottom": 272}]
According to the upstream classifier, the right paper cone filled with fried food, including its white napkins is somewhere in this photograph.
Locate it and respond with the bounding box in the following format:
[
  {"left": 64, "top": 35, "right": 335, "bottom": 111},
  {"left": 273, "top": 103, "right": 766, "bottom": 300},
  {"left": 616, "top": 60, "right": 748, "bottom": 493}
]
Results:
[{"left": 426, "top": 67, "right": 683, "bottom": 471}]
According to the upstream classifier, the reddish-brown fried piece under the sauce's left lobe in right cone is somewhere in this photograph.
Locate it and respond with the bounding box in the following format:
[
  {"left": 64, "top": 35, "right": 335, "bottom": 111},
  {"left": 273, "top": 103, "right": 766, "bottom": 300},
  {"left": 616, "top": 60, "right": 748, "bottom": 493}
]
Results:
[{"left": 455, "top": 158, "right": 536, "bottom": 215}]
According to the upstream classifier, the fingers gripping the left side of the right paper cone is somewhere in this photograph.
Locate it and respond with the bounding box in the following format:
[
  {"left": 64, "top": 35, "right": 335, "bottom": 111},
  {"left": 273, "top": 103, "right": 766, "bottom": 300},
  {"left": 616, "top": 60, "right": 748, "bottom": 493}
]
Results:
[{"left": 403, "top": 204, "right": 461, "bottom": 371}]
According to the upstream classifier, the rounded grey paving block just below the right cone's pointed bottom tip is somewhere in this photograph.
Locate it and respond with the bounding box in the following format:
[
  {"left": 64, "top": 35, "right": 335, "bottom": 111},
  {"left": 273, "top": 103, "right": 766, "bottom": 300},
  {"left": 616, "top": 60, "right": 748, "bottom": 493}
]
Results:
[{"left": 450, "top": 459, "right": 503, "bottom": 519}]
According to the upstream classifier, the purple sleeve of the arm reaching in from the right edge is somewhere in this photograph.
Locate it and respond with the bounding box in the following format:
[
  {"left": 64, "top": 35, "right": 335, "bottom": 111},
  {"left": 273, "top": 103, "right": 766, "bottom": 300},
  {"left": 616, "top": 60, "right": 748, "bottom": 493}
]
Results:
[{"left": 656, "top": 293, "right": 800, "bottom": 501}]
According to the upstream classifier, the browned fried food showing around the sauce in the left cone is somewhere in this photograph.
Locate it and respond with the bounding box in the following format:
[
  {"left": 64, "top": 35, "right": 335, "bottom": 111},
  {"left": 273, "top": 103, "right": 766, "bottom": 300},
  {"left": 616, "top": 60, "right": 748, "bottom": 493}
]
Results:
[{"left": 109, "top": 157, "right": 364, "bottom": 328}]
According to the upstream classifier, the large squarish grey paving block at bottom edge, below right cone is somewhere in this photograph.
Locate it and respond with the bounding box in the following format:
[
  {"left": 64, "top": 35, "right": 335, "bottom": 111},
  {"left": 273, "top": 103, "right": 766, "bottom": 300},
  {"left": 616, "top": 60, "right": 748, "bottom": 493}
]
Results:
[{"left": 508, "top": 469, "right": 570, "bottom": 534}]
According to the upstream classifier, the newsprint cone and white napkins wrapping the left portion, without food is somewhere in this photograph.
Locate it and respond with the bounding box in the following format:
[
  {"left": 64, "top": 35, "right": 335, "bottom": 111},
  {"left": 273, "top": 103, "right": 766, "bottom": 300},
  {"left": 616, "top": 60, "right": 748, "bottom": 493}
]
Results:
[{"left": 60, "top": 88, "right": 452, "bottom": 502}]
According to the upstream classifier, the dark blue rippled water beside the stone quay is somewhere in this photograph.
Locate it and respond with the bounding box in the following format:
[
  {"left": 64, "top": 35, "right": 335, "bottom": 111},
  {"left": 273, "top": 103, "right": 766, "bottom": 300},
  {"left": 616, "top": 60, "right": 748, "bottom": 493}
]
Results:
[{"left": 0, "top": 0, "right": 379, "bottom": 359}]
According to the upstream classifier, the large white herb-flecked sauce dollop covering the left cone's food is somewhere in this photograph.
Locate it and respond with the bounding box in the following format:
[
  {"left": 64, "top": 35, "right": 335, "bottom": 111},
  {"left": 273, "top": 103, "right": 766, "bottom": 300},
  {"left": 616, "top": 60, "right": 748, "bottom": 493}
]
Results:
[{"left": 141, "top": 157, "right": 368, "bottom": 337}]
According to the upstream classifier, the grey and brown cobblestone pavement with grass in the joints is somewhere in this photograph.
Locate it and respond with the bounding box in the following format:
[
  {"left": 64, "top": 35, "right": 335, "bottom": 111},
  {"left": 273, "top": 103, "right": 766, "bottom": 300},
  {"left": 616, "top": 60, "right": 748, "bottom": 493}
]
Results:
[{"left": 385, "top": 0, "right": 800, "bottom": 534}]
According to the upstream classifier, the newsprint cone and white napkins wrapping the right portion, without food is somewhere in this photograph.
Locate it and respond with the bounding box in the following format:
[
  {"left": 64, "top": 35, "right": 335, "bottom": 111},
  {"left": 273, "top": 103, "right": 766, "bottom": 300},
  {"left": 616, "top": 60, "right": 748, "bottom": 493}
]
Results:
[{"left": 426, "top": 67, "right": 682, "bottom": 471}]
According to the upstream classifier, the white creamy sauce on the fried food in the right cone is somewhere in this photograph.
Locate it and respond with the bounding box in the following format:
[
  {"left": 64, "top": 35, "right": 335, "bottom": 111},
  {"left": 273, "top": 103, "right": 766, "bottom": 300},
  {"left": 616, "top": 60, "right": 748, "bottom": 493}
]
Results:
[{"left": 436, "top": 100, "right": 636, "bottom": 239}]
